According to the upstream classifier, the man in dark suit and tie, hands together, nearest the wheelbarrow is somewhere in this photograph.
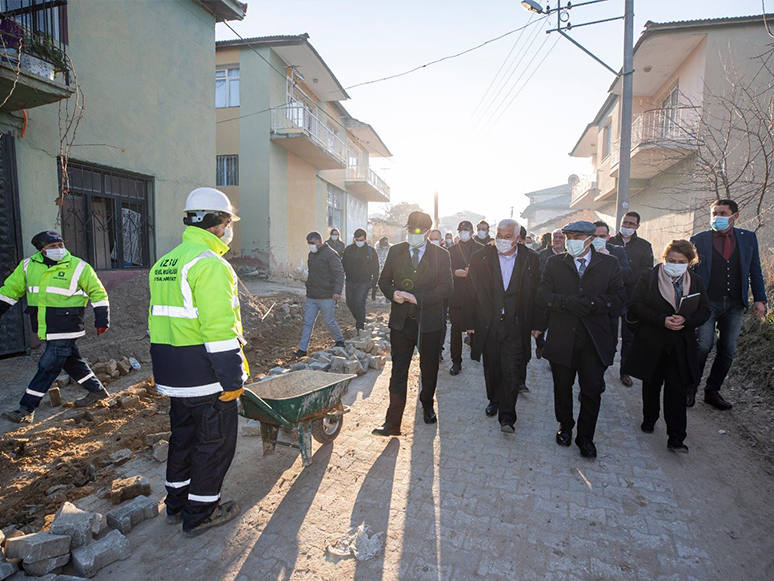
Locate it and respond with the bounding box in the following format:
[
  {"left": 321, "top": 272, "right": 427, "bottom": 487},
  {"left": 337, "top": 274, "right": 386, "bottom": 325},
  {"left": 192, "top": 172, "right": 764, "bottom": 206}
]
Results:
[{"left": 373, "top": 212, "right": 453, "bottom": 436}]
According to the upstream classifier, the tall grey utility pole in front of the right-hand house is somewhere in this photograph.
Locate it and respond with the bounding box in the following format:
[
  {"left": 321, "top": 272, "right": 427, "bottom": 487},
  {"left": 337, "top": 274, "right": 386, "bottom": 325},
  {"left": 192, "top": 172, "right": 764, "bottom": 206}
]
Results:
[{"left": 615, "top": 0, "right": 634, "bottom": 230}]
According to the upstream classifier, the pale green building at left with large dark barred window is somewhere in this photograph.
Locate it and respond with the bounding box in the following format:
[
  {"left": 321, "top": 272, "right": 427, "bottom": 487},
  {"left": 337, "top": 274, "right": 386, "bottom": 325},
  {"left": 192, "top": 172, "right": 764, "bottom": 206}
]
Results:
[{"left": 0, "top": 0, "right": 247, "bottom": 356}]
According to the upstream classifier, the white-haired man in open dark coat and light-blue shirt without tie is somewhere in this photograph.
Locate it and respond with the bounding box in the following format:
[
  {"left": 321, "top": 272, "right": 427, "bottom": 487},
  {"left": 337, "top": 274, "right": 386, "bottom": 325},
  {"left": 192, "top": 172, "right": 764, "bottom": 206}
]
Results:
[{"left": 464, "top": 219, "right": 544, "bottom": 434}]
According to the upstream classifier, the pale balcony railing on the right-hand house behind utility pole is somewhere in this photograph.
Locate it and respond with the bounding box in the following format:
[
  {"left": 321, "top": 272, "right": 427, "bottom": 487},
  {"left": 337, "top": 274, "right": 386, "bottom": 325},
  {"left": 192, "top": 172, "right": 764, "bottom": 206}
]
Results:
[{"left": 610, "top": 107, "right": 701, "bottom": 166}]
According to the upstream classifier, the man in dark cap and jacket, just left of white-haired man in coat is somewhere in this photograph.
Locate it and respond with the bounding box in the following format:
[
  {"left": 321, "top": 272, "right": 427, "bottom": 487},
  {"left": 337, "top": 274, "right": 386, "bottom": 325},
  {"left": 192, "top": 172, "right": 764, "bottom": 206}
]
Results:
[{"left": 449, "top": 220, "right": 484, "bottom": 375}]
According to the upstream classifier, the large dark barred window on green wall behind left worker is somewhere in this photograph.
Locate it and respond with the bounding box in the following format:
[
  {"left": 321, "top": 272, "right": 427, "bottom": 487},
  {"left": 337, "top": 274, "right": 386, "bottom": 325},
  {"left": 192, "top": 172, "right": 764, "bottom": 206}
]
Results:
[{"left": 62, "top": 163, "right": 153, "bottom": 270}]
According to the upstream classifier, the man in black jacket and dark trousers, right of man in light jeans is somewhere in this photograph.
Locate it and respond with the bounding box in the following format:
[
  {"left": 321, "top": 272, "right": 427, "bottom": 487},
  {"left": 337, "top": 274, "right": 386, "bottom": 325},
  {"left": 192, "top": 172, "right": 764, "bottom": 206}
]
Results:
[{"left": 341, "top": 228, "right": 379, "bottom": 330}]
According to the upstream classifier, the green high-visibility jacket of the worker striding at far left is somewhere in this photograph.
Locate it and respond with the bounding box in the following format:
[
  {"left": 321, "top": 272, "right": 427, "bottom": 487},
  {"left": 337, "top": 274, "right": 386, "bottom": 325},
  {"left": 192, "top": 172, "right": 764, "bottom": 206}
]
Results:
[{"left": 0, "top": 252, "right": 110, "bottom": 341}]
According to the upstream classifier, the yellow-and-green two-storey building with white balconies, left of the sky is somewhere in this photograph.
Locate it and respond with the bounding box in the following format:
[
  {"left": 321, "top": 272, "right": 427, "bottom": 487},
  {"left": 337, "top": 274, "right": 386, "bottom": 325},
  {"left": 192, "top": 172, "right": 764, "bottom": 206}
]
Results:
[{"left": 215, "top": 34, "right": 391, "bottom": 273}]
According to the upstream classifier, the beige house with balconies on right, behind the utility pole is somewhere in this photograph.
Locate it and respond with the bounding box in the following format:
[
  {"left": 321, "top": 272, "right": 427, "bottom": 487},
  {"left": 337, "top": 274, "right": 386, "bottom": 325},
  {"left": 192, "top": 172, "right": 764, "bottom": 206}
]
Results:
[{"left": 570, "top": 16, "right": 772, "bottom": 254}]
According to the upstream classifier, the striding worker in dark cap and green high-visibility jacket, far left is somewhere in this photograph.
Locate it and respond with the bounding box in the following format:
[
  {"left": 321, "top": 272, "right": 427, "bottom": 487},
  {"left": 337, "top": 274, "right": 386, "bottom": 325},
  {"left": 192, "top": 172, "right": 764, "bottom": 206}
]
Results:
[{"left": 0, "top": 231, "right": 110, "bottom": 424}]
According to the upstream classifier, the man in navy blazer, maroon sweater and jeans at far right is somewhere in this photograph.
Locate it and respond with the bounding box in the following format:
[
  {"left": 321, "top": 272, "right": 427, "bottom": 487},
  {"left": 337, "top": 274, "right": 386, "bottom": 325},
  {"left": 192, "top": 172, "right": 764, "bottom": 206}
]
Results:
[{"left": 688, "top": 200, "right": 767, "bottom": 410}]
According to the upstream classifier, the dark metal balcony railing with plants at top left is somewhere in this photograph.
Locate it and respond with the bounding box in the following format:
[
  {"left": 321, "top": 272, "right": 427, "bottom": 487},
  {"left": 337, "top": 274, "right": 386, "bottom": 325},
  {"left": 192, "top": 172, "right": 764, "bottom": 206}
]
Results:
[{"left": 0, "top": 0, "right": 70, "bottom": 85}]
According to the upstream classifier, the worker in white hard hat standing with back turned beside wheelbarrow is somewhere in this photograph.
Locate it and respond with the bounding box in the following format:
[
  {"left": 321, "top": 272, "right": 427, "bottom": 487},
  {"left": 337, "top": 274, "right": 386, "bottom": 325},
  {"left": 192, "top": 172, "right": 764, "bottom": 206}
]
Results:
[{"left": 148, "top": 188, "right": 248, "bottom": 537}]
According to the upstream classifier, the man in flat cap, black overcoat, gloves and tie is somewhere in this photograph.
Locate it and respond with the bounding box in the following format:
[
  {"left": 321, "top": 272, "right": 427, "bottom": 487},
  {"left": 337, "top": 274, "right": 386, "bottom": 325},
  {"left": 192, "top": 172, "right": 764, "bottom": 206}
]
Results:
[{"left": 536, "top": 221, "right": 626, "bottom": 458}]
